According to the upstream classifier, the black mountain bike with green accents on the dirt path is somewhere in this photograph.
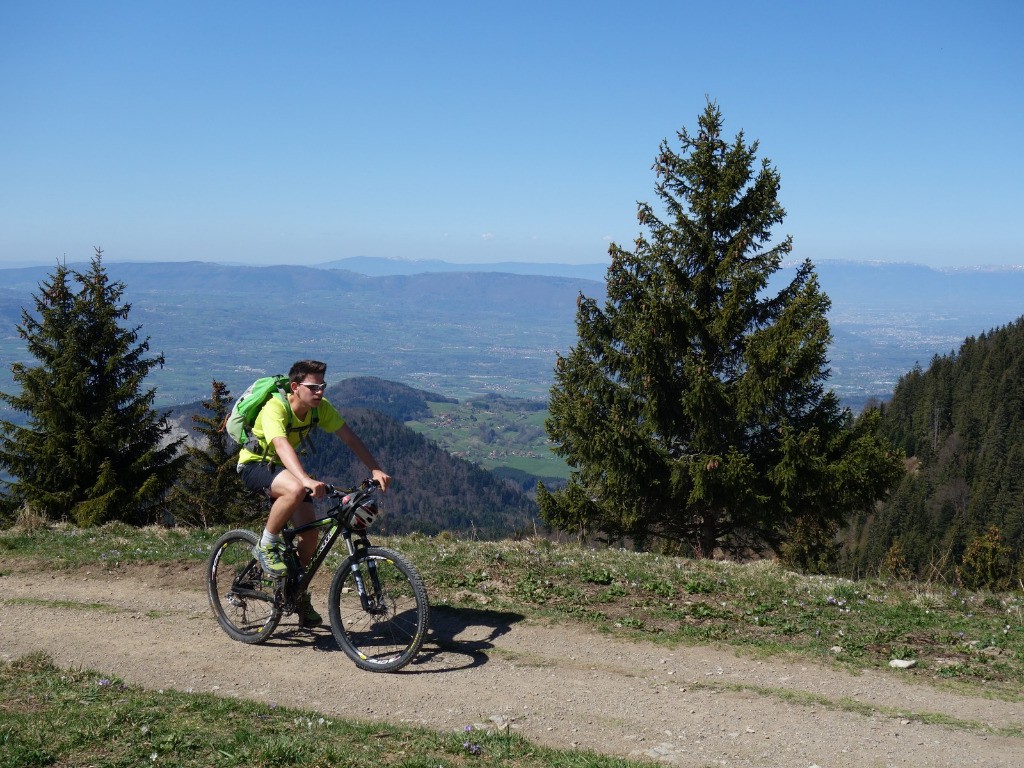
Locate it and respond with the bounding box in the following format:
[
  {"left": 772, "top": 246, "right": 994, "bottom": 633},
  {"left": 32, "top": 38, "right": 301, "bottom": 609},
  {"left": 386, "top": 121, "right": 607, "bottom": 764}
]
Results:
[{"left": 206, "top": 480, "right": 430, "bottom": 672}]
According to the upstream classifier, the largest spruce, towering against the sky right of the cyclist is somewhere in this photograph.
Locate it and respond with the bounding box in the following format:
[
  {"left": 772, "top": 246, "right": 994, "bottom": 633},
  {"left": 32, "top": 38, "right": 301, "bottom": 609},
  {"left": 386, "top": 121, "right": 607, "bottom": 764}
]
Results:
[{"left": 539, "top": 102, "right": 901, "bottom": 557}]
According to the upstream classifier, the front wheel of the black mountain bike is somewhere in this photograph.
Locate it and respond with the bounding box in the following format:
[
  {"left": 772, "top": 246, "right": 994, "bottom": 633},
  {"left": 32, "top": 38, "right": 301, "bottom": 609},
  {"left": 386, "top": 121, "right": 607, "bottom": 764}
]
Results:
[{"left": 328, "top": 547, "right": 430, "bottom": 672}]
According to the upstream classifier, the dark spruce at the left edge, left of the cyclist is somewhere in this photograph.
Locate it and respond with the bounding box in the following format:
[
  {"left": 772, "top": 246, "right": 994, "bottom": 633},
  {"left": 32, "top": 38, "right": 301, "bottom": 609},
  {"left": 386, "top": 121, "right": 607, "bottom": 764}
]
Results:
[{"left": 0, "top": 249, "right": 181, "bottom": 525}]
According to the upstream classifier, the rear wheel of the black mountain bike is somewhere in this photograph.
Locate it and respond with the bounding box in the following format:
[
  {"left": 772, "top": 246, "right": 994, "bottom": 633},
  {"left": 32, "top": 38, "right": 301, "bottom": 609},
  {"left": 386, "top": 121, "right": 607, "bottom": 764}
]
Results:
[{"left": 206, "top": 529, "right": 281, "bottom": 643}]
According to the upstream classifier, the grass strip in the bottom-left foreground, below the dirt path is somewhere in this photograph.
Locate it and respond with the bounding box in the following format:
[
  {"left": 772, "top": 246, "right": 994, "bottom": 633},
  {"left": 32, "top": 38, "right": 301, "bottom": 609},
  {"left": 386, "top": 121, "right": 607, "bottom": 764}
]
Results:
[{"left": 0, "top": 655, "right": 649, "bottom": 768}]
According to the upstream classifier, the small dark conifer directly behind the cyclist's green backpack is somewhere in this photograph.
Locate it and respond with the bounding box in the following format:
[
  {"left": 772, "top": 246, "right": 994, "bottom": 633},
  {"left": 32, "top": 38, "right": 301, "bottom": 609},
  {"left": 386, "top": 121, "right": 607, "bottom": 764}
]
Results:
[{"left": 170, "top": 381, "right": 258, "bottom": 527}]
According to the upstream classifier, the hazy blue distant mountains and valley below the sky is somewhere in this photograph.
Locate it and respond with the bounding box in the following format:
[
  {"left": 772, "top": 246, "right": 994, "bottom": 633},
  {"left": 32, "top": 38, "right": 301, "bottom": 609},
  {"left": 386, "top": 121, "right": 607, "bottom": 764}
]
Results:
[{"left": 0, "top": 257, "right": 1024, "bottom": 410}]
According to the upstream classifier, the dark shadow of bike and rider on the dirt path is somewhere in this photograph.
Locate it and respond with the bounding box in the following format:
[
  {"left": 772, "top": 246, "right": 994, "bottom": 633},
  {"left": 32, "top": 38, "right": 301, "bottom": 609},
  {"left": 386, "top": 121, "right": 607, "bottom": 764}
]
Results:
[{"left": 266, "top": 606, "right": 524, "bottom": 675}]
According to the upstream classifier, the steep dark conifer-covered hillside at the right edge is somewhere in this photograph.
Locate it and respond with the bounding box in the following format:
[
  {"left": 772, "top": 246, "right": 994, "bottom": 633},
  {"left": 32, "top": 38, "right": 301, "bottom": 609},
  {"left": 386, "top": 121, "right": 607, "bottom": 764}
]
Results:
[{"left": 848, "top": 317, "right": 1024, "bottom": 575}]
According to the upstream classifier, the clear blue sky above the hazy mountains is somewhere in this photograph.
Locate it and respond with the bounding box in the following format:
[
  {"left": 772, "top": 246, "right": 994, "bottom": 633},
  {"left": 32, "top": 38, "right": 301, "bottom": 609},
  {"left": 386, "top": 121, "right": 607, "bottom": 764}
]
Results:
[{"left": 0, "top": 0, "right": 1024, "bottom": 267}]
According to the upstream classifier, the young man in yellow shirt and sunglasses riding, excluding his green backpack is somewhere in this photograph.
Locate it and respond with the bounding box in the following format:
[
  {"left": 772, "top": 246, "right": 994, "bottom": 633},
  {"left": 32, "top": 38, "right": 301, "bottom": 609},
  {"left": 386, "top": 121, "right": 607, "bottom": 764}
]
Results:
[{"left": 238, "top": 360, "right": 391, "bottom": 627}]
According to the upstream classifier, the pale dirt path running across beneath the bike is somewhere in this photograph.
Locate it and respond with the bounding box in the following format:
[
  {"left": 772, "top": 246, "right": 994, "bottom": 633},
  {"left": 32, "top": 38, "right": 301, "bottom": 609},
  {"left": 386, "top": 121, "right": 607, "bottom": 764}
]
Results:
[{"left": 0, "top": 565, "right": 1024, "bottom": 768}]
